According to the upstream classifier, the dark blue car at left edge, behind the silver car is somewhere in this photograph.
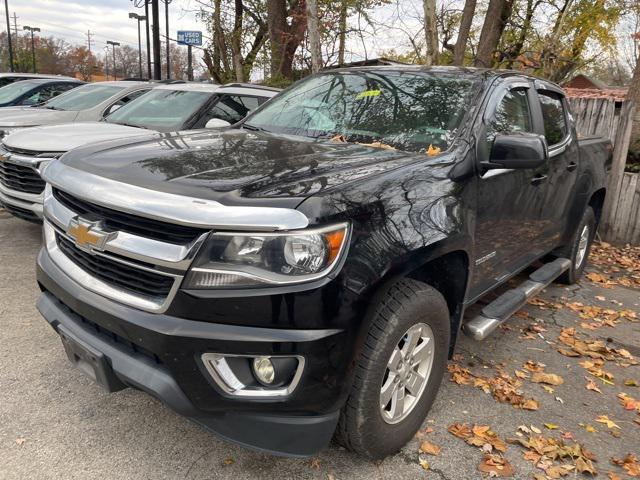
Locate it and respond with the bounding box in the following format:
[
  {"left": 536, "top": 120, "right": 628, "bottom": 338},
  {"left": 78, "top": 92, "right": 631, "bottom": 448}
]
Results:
[{"left": 0, "top": 78, "right": 84, "bottom": 107}]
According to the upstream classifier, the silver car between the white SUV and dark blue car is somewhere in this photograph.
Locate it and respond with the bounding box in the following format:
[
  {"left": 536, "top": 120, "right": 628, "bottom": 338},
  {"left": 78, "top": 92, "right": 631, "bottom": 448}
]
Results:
[{"left": 0, "top": 81, "right": 155, "bottom": 138}]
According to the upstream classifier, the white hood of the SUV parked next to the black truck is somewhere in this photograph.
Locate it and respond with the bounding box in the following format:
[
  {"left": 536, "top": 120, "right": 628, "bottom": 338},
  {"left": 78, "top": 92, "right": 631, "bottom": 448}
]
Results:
[{"left": 3, "top": 122, "right": 149, "bottom": 152}]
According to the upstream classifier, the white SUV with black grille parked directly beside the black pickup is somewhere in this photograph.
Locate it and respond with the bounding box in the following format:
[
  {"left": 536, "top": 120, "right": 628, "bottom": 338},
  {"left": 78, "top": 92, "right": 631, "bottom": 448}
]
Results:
[{"left": 0, "top": 83, "right": 278, "bottom": 221}]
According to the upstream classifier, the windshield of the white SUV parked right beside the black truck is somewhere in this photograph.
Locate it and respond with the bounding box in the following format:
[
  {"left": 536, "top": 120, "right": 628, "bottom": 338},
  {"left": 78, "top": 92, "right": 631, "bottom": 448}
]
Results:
[{"left": 106, "top": 88, "right": 212, "bottom": 132}]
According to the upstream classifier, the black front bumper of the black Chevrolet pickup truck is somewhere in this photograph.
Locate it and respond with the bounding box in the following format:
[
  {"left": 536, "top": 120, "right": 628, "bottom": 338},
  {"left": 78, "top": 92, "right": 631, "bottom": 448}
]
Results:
[{"left": 38, "top": 250, "right": 350, "bottom": 456}]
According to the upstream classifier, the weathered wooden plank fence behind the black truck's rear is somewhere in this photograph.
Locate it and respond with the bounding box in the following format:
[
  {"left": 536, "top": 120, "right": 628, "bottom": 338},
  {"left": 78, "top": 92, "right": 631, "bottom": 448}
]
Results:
[{"left": 569, "top": 97, "right": 640, "bottom": 245}]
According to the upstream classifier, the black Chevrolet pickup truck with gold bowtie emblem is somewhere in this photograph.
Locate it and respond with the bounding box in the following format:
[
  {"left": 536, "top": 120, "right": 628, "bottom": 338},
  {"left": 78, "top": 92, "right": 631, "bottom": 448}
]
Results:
[{"left": 33, "top": 66, "right": 611, "bottom": 458}]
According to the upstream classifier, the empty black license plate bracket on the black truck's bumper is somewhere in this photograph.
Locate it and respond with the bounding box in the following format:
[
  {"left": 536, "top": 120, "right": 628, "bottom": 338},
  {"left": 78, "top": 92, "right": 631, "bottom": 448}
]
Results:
[{"left": 58, "top": 325, "right": 127, "bottom": 392}]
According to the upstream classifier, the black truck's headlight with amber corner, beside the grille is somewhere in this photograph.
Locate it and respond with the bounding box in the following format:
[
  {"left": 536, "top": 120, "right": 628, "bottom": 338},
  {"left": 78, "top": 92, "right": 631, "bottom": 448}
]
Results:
[{"left": 184, "top": 223, "right": 349, "bottom": 289}]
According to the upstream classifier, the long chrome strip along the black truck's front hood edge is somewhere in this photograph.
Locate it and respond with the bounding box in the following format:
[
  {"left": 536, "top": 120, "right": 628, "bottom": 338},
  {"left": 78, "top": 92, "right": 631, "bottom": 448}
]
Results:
[{"left": 42, "top": 161, "right": 309, "bottom": 231}]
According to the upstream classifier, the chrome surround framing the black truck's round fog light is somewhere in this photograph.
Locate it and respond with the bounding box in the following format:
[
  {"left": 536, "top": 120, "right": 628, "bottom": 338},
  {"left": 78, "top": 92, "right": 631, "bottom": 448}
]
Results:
[{"left": 201, "top": 353, "right": 305, "bottom": 398}]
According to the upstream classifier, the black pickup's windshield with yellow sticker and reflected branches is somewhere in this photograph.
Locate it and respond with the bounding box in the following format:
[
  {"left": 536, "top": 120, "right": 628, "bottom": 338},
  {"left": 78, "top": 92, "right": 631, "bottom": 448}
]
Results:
[{"left": 246, "top": 71, "right": 475, "bottom": 152}]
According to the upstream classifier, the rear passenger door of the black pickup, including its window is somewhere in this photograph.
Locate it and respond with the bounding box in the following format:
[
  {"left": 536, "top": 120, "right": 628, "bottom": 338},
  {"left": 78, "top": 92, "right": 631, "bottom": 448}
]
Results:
[{"left": 536, "top": 86, "right": 579, "bottom": 250}]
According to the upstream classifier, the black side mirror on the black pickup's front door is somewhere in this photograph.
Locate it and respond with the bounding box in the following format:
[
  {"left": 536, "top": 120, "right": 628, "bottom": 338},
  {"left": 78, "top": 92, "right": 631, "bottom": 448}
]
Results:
[{"left": 482, "top": 134, "right": 547, "bottom": 170}]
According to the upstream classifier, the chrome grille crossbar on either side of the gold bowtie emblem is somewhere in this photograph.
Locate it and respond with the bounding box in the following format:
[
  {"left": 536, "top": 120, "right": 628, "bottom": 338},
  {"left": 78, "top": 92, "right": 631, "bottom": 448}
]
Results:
[{"left": 44, "top": 185, "right": 209, "bottom": 271}]
